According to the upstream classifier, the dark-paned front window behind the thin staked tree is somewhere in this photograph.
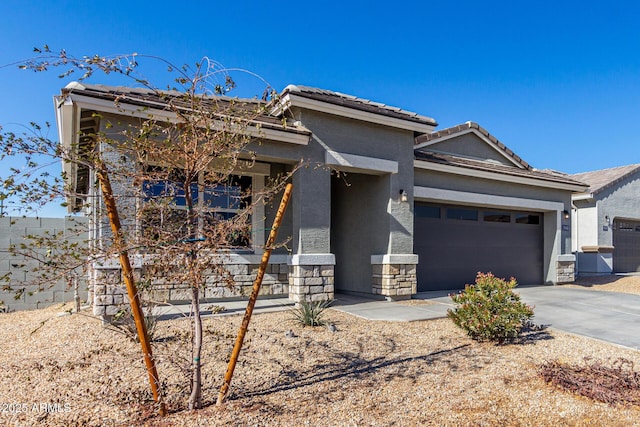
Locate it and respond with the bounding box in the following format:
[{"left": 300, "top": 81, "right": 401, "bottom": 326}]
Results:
[{"left": 141, "top": 168, "right": 255, "bottom": 249}]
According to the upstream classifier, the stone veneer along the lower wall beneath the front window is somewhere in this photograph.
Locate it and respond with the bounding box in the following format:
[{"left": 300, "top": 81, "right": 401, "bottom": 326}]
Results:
[{"left": 89, "top": 256, "right": 289, "bottom": 317}]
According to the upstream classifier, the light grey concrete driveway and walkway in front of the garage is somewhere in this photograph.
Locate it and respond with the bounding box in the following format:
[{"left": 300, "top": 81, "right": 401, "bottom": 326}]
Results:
[{"left": 333, "top": 285, "right": 640, "bottom": 350}]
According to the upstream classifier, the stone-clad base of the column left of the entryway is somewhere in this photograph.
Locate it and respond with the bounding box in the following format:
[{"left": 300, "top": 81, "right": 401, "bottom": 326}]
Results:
[{"left": 289, "top": 254, "right": 336, "bottom": 303}]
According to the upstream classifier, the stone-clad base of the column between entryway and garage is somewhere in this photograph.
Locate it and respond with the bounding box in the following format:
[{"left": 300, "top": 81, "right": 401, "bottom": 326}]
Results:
[{"left": 371, "top": 254, "right": 418, "bottom": 301}]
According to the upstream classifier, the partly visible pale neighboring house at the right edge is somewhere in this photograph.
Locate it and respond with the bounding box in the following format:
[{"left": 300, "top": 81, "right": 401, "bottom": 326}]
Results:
[{"left": 571, "top": 164, "right": 640, "bottom": 274}]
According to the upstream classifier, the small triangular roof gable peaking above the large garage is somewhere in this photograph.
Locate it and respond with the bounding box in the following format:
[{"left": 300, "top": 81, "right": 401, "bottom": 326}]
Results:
[{"left": 415, "top": 122, "right": 533, "bottom": 170}]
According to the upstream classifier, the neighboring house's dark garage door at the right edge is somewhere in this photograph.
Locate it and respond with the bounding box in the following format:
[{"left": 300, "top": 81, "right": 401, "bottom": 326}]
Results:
[{"left": 613, "top": 218, "right": 640, "bottom": 273}]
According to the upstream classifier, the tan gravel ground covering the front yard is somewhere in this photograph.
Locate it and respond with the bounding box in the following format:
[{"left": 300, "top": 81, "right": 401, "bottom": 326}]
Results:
[{"left": 0, "top": 277, "right": 640, "bottom": 426}]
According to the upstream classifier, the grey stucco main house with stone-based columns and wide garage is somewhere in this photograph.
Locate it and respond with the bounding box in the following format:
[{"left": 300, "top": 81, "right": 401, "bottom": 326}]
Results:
[{"left": 57, "top": 83, "right": 586, "bottom": 315}]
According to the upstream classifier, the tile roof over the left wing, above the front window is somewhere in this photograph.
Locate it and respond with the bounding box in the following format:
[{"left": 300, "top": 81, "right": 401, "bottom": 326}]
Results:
[{"left": 62, "top": 82, "right": 310, "bottom": 134}]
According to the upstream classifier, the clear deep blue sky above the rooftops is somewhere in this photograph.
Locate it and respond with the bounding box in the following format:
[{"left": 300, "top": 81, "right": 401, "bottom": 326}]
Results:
[{"left": 0, "top": 0, "right": 640, "bottom": 214}]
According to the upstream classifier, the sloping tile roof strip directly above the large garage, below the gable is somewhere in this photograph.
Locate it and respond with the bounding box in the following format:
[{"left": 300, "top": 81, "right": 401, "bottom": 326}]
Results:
[{"left": 415, "top": 150, "right": 584, "bottom": 186}]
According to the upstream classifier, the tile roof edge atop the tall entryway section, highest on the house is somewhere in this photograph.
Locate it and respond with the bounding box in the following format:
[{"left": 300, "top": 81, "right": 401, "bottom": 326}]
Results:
[{"left": 281, "top": 85, "right": 438, "bottom": 126}]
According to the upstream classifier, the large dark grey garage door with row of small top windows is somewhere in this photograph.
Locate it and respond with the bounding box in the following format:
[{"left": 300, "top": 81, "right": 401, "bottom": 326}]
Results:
[{"left": 414, "top": 203, "right": 544, "bottom": 292}]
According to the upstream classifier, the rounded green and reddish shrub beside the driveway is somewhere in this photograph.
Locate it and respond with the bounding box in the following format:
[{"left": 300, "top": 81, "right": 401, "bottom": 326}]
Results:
[{"left": 447, "top": 273, "right": 533, "bottom": 343}]
